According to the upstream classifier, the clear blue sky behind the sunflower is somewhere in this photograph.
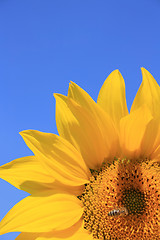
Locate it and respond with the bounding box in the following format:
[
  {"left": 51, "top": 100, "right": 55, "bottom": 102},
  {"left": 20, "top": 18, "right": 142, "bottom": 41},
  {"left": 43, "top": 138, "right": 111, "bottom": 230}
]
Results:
[{"left": 0, "top": 0, "right": 160, "bottom": 240}]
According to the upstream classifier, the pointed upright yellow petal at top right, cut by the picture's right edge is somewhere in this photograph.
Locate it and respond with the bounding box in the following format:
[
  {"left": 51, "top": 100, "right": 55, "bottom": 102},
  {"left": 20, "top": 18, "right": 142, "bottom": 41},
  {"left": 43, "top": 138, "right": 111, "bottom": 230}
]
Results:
[{"left": 131, "top": 68, "right": 160, "bottom": 118}]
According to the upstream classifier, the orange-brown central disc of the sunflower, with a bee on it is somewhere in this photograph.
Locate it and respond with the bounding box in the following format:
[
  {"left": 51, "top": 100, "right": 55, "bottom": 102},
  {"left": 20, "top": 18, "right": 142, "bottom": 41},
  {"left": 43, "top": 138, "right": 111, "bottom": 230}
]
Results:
[{"left": 79, "top": 159, "right": 160, "bottom": 240}]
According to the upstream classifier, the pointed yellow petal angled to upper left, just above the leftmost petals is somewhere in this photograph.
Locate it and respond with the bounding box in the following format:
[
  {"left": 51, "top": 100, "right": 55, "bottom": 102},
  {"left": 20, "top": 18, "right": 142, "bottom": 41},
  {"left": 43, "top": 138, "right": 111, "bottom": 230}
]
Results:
[{"left": 20, "top": 130, "right": 90, "bottom": 186}]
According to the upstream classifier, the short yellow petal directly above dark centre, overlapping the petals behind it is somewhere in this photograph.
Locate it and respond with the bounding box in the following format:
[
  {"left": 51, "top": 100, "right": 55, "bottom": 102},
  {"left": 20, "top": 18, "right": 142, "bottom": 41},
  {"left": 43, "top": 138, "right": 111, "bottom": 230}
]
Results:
[{"left": 120, "top": 105, "right": 152, "bottom": 159}]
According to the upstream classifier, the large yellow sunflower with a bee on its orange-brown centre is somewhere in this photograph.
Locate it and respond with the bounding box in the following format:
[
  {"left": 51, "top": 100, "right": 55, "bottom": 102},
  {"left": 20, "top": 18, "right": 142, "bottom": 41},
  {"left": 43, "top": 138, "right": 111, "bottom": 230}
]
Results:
[{"left": 0, "top": 69, "right": 160, "bottom": 240}]
